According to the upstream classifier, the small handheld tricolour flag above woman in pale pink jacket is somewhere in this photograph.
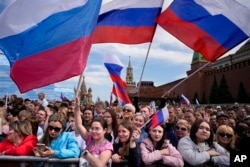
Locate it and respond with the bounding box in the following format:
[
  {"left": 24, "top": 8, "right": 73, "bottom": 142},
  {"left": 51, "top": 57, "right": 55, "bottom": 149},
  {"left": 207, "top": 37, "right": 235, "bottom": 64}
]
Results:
[{"left": 150, "top": 105, "right": 169, "bottom": 129}]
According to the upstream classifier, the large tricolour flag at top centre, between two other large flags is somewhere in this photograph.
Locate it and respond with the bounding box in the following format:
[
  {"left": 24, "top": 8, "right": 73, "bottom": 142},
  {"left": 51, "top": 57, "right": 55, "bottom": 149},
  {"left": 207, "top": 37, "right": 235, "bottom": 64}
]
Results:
[{"left": 93, "top": 0, "right": 163, "bottom": 44}]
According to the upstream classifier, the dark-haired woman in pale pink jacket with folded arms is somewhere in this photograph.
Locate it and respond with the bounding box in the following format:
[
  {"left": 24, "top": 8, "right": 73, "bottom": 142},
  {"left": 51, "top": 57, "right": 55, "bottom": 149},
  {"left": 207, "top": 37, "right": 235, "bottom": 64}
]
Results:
[{"left": 140, "top": 125, "right": 184, "bottom": 167}]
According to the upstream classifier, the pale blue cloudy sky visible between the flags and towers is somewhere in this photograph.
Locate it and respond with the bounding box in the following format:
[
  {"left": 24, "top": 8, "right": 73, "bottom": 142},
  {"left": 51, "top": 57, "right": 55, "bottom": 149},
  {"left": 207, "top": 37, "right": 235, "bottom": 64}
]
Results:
[{"left": 0, "top": 0, "right": 250, "bottom": 101}]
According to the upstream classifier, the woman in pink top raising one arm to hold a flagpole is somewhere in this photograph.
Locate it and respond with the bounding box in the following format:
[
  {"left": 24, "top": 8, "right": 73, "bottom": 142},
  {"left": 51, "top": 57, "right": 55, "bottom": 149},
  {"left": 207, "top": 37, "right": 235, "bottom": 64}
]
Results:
[{"left": 75, "top": 98, "right": 113, "bottom": 167}]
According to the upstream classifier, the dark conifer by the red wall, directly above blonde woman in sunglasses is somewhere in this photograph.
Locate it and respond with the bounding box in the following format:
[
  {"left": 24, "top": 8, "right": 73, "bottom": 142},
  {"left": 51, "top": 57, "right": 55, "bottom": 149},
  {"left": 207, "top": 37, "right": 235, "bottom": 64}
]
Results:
[{"left": 218, "top": 74, "right": 234, "bottom": 103}]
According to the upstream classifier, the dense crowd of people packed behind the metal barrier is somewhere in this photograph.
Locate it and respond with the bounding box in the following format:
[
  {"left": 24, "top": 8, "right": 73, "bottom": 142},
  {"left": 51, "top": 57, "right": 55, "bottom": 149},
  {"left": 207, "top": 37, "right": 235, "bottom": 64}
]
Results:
[{"left": 0, "top": 92, "right": 250, "bottom": 167}]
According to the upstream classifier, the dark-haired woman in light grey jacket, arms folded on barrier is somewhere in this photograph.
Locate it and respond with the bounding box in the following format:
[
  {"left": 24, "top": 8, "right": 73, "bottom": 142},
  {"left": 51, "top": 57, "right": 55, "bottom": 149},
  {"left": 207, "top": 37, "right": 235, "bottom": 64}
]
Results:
[{"left": 178, "top": 119, "right": 219, "bottom": 167}]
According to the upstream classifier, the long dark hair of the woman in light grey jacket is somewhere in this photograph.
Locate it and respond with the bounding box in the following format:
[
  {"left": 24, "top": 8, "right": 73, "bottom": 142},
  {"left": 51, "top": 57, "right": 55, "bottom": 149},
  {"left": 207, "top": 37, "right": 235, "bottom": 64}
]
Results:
[{"left": 190, "top": 119, "right": 214, "bottom": 147}]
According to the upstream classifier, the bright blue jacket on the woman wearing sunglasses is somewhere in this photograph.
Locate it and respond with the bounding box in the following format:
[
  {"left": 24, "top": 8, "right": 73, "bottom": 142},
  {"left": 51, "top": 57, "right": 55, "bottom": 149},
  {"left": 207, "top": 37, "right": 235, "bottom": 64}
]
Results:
[{"left": 50, "top": 132, "right": 80, "bottom": 159}]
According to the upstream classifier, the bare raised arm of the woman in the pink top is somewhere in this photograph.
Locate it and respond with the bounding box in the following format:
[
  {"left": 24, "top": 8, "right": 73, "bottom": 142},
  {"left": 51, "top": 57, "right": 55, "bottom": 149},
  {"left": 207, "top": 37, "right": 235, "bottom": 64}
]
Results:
[{"left": 75, "top": 97, "right": 89, "bottom": 141}]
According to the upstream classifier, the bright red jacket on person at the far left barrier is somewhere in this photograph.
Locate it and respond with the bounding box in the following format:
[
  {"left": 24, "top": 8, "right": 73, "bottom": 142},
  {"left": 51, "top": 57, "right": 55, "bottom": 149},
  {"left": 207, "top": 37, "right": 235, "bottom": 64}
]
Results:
[{"left": 0, "top": 135, "right": 38, "bottom": 156}]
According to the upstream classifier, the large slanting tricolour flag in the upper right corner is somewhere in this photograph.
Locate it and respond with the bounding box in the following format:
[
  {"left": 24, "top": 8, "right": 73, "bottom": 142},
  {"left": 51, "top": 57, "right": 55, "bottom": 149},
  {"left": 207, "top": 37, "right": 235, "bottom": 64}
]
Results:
[{"left": 157, "top": 0, "right": 250, "bottom": 62}]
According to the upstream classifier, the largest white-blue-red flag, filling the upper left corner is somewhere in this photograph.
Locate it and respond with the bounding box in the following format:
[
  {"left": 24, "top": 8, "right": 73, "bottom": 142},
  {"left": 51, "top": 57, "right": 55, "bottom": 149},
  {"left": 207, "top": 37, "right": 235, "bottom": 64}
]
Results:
[{"left": 0, "top": 0, "right": 101, "bottom": 93}]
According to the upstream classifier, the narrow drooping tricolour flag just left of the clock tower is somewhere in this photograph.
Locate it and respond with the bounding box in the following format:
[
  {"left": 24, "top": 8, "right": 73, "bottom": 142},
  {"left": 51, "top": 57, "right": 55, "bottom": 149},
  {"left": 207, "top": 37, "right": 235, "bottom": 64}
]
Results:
[{"left": 104, "top": 55, "right": 131, "bottom": 104}]
